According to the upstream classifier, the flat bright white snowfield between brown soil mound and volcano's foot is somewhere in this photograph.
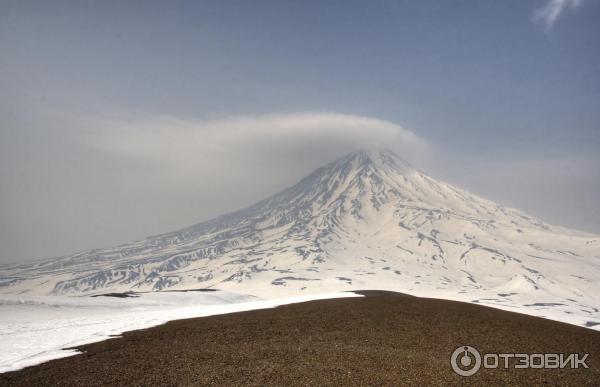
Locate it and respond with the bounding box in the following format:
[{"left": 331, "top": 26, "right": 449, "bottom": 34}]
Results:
[{"left": 0, "top": 291, "right": 362, "bottom": 373}]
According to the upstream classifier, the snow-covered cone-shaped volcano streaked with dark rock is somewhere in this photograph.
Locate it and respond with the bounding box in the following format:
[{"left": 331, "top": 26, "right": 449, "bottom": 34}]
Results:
[{"left": 0, "top": 150, "right": 600, "bottom": 327}]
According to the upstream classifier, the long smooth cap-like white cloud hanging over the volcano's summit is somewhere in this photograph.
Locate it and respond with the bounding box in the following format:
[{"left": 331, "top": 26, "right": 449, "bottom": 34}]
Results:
[{"left": 87, "top": 112, "right": 429, "bottom": 180}]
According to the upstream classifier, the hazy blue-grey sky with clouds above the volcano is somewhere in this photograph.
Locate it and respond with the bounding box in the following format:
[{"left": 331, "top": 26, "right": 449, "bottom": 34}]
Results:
[{"left": 0, "top": 0, "right": 600, "bottom": 262}]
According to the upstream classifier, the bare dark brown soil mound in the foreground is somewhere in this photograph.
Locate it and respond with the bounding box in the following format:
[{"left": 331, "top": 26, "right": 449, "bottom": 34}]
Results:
[{"left": 0, "top": 292, "right": 600, "bottom": 386}]
